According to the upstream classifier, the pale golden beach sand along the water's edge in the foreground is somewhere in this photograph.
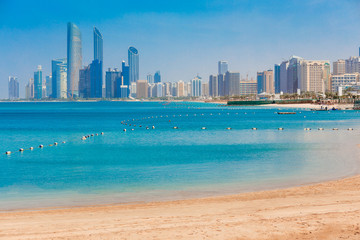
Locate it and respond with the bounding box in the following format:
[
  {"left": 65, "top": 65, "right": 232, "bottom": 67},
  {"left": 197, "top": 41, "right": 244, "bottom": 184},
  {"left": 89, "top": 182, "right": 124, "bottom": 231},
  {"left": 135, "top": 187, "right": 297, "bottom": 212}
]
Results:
[{"left": 0, "top": 176, "right": 360, "bottom": 240}]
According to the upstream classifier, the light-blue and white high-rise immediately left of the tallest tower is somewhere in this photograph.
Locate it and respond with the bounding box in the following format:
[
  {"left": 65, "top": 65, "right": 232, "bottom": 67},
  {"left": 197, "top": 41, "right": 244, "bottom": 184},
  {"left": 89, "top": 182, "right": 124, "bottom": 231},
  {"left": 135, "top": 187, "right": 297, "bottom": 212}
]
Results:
[{"left": 51, "top": 58, "right": 68, "bottom": 98}]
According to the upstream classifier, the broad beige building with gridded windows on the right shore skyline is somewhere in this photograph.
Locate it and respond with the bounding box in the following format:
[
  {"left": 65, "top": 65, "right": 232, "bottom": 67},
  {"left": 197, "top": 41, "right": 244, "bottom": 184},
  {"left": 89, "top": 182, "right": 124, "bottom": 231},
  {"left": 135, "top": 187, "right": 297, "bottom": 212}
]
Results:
[{"left": 298, "top": 60, "right": 331, "bottom": 93}]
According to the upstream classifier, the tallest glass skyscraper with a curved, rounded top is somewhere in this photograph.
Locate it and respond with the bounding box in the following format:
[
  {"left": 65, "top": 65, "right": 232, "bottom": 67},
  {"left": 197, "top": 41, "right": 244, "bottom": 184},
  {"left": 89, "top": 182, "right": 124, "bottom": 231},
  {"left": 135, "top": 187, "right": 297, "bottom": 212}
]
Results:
[{"left": 67, "top": 22, "right": 82, "bottom": 98}]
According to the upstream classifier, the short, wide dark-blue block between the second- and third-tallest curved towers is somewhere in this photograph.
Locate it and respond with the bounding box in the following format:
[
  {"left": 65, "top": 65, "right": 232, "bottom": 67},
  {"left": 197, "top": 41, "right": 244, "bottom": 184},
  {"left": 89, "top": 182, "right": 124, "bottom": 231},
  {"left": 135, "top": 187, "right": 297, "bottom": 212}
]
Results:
[{"left": 105, "top": 68, "right": 123, "bottom": 98}]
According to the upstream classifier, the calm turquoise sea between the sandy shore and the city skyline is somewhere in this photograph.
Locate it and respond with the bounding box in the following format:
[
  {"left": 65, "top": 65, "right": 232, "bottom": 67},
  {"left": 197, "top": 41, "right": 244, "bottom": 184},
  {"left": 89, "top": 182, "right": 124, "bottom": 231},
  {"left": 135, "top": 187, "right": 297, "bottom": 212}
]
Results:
[{"left": 0, "top": 102, "right": 360, "bottom": 210}]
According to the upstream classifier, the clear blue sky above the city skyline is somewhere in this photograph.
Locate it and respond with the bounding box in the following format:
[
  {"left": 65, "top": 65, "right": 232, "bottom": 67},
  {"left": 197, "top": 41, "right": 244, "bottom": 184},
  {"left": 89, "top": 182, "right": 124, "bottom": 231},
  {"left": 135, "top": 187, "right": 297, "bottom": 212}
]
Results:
[{"left": 0, "top": 0, "right": 360, "bottom": 98}]
